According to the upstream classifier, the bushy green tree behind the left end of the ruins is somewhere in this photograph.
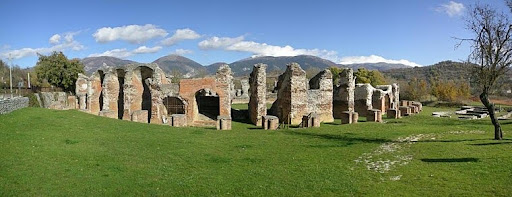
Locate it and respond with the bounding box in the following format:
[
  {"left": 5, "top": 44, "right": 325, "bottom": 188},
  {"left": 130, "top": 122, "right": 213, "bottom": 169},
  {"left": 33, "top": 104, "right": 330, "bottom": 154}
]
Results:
[{"left": 35, "top": 51, "right": 85, "bottom": 91}]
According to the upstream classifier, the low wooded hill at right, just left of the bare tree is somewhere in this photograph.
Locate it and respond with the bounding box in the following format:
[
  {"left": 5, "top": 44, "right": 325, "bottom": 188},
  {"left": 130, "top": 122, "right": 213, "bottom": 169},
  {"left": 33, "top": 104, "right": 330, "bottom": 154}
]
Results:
[{"left": 382, "top": 61, "right": 473, "bottom": 82}]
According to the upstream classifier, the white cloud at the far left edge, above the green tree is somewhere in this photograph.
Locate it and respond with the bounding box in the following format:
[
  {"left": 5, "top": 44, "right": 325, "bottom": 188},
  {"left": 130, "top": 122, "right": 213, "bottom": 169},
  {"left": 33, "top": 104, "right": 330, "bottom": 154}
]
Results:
[{"left": 0, "top": 32, "right": 85, "bottom": 59}]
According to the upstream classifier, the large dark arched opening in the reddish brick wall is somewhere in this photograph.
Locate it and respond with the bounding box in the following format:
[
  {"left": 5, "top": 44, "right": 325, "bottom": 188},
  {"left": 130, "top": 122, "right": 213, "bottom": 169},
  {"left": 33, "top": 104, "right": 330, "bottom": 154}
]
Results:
[{"left": 195, "top": 89, "right": 220, "bottom": 120}]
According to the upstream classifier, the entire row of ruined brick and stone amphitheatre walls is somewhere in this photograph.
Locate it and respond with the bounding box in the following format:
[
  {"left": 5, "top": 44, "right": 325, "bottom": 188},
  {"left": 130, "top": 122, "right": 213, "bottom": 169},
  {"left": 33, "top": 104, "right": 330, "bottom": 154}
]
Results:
[{"left": 64, "top": 63, "right": 422, "bottom": 130}]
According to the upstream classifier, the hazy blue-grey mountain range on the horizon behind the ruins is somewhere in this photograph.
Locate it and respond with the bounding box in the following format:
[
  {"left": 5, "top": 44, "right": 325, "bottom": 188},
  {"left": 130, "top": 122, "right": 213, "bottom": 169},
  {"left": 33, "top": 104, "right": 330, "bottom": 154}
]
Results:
[{"left": 81, "top": 55, "right": 416, "bottom": 78}]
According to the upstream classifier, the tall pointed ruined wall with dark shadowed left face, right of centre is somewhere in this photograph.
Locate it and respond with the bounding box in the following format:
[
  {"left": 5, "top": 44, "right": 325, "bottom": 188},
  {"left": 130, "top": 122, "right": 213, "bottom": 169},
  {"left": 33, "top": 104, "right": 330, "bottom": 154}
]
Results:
[{"left": 270, "top": 63, "right": 308, "bottom": 124}]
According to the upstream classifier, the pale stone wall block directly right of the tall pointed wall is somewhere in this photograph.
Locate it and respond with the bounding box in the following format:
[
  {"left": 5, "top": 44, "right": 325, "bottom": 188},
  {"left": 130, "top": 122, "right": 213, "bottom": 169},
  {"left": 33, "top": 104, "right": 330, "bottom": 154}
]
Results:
[{"left": 307, "top": 69, "right": 334, "bottom": 122}]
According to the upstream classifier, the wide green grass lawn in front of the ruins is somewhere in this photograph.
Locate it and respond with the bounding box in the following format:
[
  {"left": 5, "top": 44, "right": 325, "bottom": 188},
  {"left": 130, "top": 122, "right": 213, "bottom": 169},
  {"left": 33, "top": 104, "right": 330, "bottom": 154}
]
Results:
[{"left": 0, "top": 106, "right": 512, "bottom": 196}]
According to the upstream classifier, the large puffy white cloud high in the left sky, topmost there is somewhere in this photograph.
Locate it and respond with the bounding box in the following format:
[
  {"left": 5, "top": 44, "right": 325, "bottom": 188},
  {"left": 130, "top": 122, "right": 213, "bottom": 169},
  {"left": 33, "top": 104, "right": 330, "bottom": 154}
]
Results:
[{"left": 93, "top": 24, "right": 169, "bottom": 44}]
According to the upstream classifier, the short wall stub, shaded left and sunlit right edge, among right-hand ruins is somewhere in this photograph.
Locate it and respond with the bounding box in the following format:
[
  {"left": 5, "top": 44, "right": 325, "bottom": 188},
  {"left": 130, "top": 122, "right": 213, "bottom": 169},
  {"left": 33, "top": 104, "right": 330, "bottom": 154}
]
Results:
[{"left": 354, "top": 83, "right": 375, "bottom": 116}]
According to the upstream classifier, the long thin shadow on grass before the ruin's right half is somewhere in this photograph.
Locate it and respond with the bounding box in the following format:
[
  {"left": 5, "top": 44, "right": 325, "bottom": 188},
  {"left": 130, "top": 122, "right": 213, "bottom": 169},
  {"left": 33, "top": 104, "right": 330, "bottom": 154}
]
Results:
[{"left": 281, "top": 130, "right": 391, "bottom": 145}]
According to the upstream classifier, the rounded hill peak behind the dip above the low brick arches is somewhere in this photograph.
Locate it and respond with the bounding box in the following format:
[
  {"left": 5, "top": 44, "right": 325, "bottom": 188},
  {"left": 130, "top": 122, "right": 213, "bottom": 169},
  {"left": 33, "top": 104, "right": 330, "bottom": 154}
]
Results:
[{"left": 153, "top": 55, "right": 207, "bottom": 78}]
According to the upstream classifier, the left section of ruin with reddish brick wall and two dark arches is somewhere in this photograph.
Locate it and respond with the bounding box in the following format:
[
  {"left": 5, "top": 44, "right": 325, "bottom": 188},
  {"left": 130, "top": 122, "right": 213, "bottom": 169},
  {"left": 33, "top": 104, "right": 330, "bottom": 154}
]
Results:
[{"left": 75, "top": 64, "right": 233, "bottom": 126}]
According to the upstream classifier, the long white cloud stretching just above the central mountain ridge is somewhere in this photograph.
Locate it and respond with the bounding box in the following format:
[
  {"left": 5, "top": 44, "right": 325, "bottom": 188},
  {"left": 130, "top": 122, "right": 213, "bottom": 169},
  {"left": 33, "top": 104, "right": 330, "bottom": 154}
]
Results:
[{"left": 199, "top": 36, "right": 339, "bottom": 61}]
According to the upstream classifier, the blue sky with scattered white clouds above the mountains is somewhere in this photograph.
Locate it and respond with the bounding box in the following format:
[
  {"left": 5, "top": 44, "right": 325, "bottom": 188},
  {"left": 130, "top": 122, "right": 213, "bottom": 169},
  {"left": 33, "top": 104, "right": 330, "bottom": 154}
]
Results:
[{"left": 0, "top": 0, "right": 505, "bottom": 67}]
